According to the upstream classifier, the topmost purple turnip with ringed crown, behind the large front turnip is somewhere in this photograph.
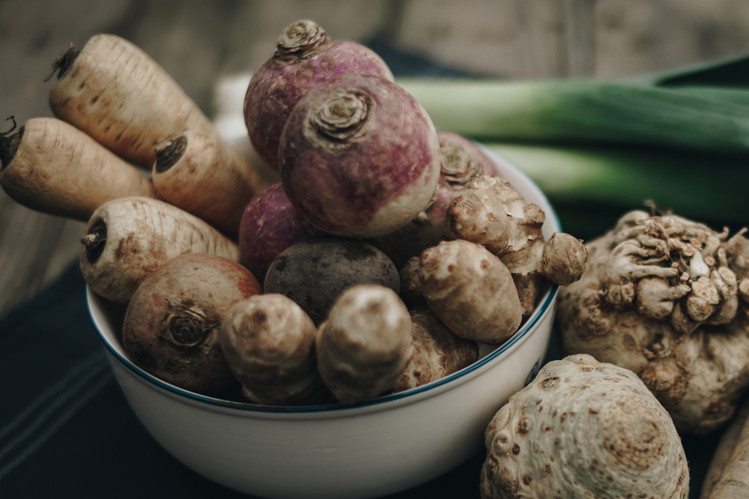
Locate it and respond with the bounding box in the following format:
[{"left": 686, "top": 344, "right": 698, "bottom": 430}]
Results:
[{"left": 244, "top": 20, "right": 393, "bottom": 170}]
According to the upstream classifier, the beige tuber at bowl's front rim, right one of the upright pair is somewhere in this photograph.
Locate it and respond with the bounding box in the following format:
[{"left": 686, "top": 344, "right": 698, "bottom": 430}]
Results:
[{"left": 315, "top": 284, "right": 411, "bottom": 404}]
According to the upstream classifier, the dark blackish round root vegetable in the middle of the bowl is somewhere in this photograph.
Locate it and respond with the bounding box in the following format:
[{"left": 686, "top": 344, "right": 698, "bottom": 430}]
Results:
[{"left": 264, "top": 237, "right": 400, "bottom": 324}]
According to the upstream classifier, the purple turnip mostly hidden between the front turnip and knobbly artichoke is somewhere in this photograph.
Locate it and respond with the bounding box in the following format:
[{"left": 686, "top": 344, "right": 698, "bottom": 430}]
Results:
[{"left": 369, "top": 130, "right": 499, "bottom": 268}]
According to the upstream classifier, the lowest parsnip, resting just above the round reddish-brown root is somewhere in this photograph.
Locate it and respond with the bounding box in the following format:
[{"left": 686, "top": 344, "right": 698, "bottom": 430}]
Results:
[{"left": 80, "top": 197, "right": 239, "bottom": 302}]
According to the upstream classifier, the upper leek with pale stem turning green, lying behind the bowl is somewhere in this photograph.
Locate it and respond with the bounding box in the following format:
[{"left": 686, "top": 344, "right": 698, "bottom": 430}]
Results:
[{"left": 399, "top": 79, "right": 749, "bottom": 155}]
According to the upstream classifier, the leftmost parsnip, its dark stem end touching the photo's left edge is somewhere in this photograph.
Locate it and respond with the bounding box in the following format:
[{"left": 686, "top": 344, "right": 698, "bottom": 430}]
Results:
[{"left": 0, "top": 117, "right": 154, "bottom": 221}]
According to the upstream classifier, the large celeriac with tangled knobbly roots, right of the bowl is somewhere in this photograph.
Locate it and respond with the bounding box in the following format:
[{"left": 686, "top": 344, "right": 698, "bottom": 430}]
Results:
[{"left": 557, "top": 210, "right": 749, "bottom": 433}]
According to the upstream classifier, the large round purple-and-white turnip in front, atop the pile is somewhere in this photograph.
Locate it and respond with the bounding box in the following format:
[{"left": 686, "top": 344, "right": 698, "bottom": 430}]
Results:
[{"left": 279, "top": 74, "right": 441, "bottom": 237}]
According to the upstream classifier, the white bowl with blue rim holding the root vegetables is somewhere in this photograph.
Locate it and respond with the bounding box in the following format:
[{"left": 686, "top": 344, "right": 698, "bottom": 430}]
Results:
[{"left": 87, "top": 145, "right": 560, "bottom": 499}]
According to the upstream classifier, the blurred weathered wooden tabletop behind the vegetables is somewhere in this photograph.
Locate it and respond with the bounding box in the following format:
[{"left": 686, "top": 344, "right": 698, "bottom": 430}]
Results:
[{"left": 0, "top": 0, "right": 749, "bottom": 317}]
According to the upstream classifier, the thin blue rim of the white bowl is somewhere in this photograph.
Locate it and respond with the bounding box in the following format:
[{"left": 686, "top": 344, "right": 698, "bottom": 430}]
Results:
[{"left": 86, "top": 144, "right": 562, "bottom": 414}]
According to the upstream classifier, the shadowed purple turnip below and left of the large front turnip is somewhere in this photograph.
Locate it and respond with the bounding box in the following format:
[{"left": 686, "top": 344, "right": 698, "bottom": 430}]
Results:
[{"left": 238, "top": 182, "right": 318, "bottom": 282}]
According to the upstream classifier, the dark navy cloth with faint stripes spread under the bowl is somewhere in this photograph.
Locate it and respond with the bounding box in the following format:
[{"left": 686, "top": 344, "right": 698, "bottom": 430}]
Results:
[{"left": 0, "top": 40, "right": 719, "bottom": 499}]
